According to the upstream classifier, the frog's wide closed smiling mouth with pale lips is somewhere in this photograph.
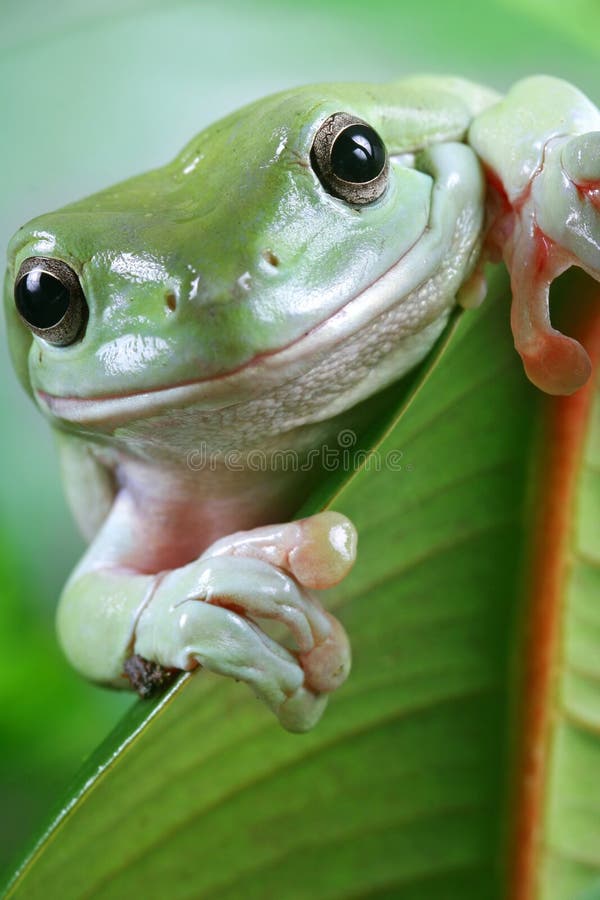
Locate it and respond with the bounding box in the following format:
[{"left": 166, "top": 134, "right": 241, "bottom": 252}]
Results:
[{"left": 34, "top": 228, "right": 442, "bottom": 431}]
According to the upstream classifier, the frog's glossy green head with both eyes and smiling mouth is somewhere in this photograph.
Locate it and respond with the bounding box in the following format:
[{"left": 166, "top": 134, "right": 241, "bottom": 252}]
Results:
[{"left": 5, "top": 81, "right": 490, "bottom": 444}]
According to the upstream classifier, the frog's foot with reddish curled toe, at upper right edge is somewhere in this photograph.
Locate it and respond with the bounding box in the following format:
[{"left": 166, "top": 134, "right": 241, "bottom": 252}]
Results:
[{"left": 496, "top": 132, "right": 600, "bottom": 394}]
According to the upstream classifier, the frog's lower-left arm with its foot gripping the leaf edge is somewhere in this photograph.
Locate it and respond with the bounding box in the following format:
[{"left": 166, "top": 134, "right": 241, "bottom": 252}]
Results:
[{"left": 57, "top": 472, "right": 356, "bottom": 731}]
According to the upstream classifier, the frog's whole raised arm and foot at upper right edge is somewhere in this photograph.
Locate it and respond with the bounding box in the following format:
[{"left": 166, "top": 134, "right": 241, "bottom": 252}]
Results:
[{"left": 469, "top": 76, "right": 600, "bottom": 394}]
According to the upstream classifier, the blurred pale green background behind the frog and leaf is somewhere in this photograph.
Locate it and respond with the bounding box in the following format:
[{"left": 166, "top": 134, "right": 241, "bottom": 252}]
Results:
[{"left": 0, "top": 0, "right": 600, "bottom": 880}]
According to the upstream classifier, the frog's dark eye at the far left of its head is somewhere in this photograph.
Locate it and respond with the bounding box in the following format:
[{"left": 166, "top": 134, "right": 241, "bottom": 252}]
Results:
[{"left": 15, "top": 256, "right": 88, "bottom": 347}]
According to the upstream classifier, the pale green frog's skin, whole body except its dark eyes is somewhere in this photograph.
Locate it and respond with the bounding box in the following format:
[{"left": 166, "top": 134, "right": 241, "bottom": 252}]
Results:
[{"left": 5, "top": 76, "right": 600, "bottom": 731}]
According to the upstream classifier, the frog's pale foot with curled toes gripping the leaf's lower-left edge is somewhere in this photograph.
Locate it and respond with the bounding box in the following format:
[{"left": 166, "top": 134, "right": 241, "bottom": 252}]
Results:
[{"left": 133, "top": 512, "right": 356, "bottom": 731}]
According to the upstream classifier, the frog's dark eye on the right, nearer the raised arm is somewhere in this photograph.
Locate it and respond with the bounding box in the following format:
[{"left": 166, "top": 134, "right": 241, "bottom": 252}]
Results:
[{"left": 310, "top": 112, "right": 389, "bottom": 206}]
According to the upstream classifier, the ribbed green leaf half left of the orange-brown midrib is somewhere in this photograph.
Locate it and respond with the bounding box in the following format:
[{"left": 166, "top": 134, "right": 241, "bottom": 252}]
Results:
[{"left": 8, "top": 262, "right": 600, "bottom": 900}]
